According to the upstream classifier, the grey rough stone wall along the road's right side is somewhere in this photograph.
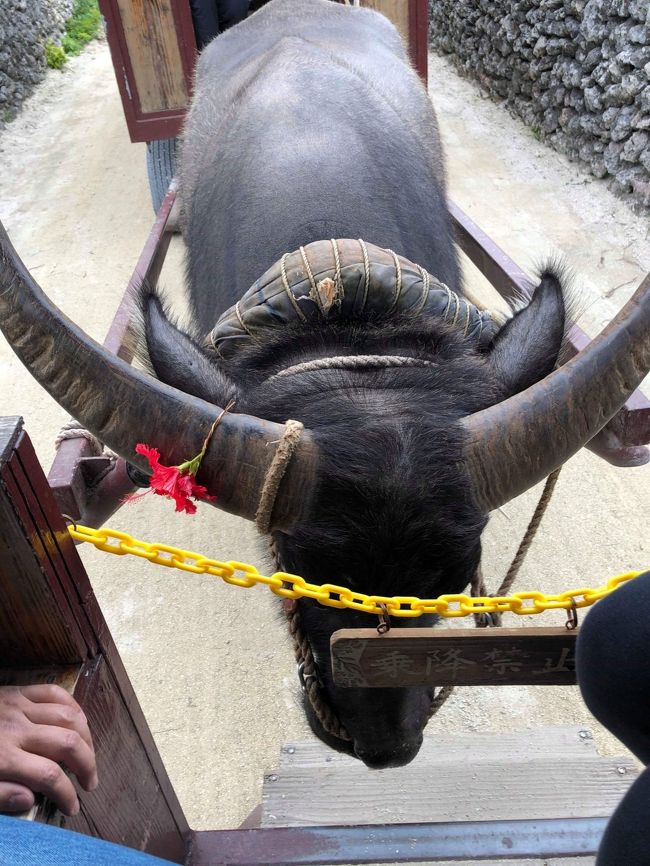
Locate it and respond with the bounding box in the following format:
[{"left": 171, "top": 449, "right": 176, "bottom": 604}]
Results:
[{"left": 429, "top": 0, "right": 650, "bottom": 207}]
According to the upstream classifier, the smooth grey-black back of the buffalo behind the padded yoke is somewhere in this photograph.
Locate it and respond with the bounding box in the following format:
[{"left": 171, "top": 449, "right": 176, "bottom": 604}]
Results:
[{"left": 181, "top": 0, "right": 460, "bottom": 324}]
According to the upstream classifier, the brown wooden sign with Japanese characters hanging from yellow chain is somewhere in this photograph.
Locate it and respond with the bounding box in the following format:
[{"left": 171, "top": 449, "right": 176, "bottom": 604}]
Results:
[{"left": 331, "top": 628, "right": 577, "bottom": 688}]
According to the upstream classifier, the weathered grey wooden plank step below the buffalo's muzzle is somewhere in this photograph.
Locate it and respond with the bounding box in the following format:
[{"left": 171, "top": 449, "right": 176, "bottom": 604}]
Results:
[{"left": 261, "top": 727, "right": 639, "bottom": 866}]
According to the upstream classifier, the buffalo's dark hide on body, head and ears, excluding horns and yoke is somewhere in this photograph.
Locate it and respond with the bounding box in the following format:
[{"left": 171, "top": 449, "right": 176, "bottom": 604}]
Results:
[{"left": 143, "top": 0, "right": 564, "bottom": 767}]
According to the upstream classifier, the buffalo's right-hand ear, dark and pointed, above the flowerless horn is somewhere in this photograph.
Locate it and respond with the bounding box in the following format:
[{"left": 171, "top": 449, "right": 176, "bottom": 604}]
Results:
[{"left": 487, "top": 271, "right": 566, "bottom": 400}]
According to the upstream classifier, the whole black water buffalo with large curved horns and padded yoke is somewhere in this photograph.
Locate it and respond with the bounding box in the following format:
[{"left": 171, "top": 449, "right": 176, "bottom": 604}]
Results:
[{"left": 0, "top": 0, "right": 650, "bottom": 767}]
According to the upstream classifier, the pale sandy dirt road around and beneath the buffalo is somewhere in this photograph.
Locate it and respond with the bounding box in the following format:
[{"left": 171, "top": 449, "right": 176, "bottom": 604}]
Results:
[{"left": 0, "top": 35, "right": 650, "bottom": 828}]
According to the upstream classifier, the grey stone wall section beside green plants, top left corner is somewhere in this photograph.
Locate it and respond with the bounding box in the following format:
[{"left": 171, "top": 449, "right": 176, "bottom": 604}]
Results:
[{"left": 0, "top": 0, "right": 74, "bottom": 123}]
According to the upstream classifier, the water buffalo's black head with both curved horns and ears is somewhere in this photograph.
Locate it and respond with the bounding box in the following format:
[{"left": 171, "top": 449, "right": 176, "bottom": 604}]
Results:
[{"left": 0, "top": 226, "right": 650, "bottom": 767}]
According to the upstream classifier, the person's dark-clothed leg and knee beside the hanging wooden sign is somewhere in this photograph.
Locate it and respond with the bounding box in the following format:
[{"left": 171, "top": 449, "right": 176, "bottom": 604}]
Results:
[{"left": 576, "top": 572, "right": 650, "bottom": 866}]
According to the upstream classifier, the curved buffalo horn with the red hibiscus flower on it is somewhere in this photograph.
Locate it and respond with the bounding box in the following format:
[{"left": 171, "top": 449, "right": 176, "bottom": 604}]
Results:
[{"left": 0, "top": 223, "right": 317, "bottom": 529}]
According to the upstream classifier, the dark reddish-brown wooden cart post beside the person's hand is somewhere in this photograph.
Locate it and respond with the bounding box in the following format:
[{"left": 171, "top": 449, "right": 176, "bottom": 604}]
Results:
[{"left": 0, "top": 418, "right": 188, "bottom": 863}]
